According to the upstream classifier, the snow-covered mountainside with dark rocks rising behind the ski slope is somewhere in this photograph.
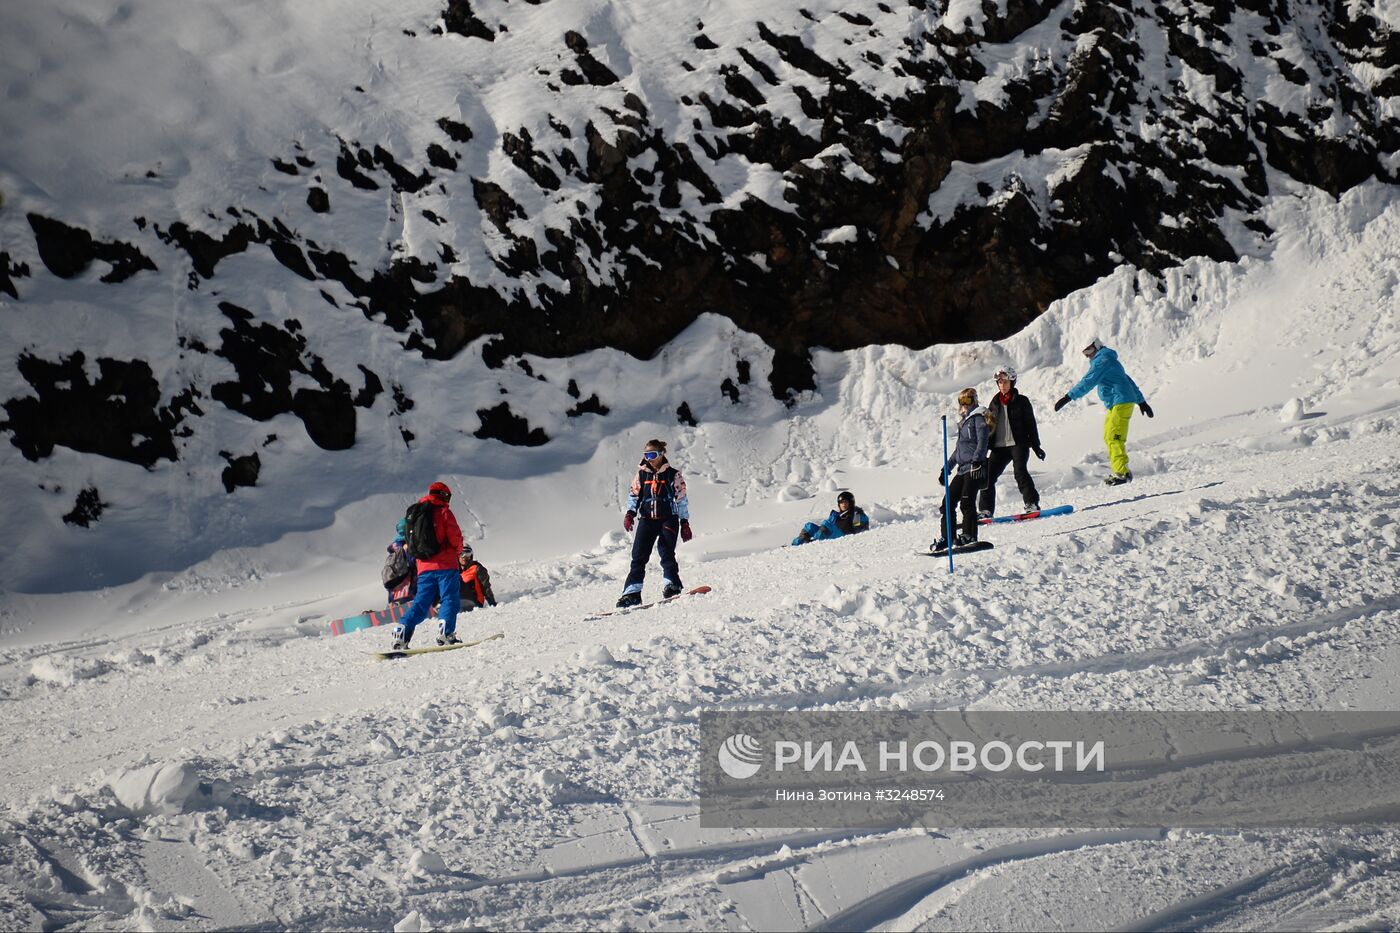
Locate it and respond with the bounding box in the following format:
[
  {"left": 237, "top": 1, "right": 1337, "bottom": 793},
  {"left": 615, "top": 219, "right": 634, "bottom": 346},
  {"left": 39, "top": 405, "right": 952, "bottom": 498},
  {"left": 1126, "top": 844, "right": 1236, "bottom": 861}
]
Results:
[{"left": 0, "top": 0, "right": 1400, "bottom": 591}]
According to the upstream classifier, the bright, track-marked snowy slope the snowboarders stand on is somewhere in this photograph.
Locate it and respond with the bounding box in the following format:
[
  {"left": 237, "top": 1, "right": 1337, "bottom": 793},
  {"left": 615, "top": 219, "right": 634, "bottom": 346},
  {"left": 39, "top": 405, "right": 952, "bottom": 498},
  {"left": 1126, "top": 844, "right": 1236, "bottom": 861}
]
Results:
[{"left": 0, "top": 177, "right": 1400, "bottom": 929}]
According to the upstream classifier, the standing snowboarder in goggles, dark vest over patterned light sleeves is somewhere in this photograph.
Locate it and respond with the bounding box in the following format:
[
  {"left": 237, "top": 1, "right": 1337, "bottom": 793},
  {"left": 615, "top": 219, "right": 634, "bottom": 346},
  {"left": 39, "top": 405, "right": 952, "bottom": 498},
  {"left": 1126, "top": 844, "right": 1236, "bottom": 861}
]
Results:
[{"left": 617, "top": 440, "right": 692, "bottom": 609}]
